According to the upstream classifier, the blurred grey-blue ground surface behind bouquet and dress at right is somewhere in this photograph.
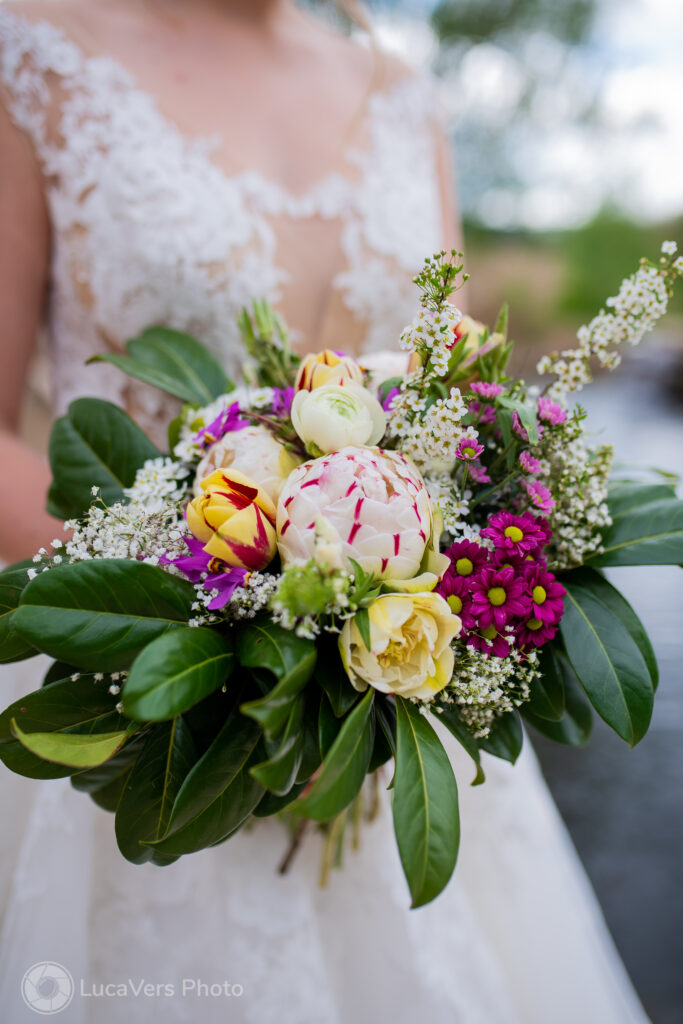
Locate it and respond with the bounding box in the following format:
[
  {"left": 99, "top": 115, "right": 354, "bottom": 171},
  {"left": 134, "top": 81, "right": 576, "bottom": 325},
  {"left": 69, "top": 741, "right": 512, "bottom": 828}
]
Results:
[{"left": 533, "top": 338, "right": 683, "bottom": 1024}]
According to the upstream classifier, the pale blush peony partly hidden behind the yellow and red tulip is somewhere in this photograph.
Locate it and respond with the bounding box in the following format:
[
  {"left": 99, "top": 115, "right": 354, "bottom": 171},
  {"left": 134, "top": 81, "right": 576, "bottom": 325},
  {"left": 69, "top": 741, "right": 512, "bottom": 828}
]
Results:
[{"left": 195, "top": 426, "right": 302, "bottom": 505}]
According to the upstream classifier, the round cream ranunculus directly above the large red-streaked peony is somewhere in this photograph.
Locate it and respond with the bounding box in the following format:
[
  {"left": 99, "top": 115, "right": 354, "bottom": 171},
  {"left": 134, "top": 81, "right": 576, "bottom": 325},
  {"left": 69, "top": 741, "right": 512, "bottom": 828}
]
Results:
[{"left": 291, "top": 381, "right": 386, "bottom": 458}]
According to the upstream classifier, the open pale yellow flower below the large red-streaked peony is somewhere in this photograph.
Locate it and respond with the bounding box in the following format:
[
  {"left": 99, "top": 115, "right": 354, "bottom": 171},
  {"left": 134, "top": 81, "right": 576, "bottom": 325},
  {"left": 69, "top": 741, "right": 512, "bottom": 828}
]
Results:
[{"left": 339, "top": 593, "right": 462, "bottom": 700}]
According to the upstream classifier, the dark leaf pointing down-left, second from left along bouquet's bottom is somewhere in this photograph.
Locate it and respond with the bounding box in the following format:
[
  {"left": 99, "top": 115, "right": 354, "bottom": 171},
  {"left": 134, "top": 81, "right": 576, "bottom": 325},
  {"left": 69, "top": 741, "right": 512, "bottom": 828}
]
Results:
[{"left": 145, "top": 714, "right": 264, "bottom": 856}]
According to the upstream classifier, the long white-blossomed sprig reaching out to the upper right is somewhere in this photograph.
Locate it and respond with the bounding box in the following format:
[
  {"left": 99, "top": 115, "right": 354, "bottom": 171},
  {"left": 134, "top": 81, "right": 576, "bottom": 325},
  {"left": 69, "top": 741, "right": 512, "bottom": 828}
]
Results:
[{"left": 537, "top": 242, "right": 683, "bottom": 400}]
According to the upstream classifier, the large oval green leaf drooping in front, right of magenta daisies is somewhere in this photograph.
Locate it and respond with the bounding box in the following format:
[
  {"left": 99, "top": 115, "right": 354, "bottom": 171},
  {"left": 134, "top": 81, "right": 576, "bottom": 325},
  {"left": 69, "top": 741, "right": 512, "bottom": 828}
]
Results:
[{"left": 560, "top": 568, "right": 654, "bottom": 746}]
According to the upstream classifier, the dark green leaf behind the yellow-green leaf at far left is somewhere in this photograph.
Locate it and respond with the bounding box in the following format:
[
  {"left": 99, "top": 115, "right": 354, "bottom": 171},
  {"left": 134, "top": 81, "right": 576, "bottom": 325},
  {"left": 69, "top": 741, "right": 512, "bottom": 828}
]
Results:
[{"left": 0, "top": 675, "right": 129, "bottom": 778}]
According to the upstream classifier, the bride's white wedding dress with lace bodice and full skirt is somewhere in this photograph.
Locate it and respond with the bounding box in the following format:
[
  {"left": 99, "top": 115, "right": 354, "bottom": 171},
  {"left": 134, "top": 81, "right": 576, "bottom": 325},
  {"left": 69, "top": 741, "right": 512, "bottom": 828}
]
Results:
[{"left": 0, "top": 6, "right": 646, "bottom": 1024}]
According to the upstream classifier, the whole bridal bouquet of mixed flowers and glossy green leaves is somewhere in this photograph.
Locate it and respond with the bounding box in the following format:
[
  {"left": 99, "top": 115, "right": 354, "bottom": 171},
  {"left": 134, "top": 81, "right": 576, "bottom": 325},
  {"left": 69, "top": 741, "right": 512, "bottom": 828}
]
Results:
[{"left": 0, "top": 243, "right": 683, "bottom": 906}]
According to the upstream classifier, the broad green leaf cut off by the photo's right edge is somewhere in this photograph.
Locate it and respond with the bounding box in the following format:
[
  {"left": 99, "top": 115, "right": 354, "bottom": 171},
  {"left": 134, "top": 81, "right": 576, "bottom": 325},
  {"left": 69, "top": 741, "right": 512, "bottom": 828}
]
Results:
[{"left": 587, "top": 498, "right": 683, "bottom": 565}]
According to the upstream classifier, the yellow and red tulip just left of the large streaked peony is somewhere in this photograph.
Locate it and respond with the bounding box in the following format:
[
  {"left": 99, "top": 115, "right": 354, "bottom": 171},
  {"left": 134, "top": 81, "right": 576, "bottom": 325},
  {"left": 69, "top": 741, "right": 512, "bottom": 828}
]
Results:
[{"left": 185, "top": 469, "right": 276, "bottom": 569}]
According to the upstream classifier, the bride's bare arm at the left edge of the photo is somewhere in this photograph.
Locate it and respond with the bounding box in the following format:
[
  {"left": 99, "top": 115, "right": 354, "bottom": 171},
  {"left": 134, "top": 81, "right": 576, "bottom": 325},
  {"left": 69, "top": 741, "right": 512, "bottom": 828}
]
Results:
[{"left": 0, "top": 97, "right": 61, "bottom": 561}]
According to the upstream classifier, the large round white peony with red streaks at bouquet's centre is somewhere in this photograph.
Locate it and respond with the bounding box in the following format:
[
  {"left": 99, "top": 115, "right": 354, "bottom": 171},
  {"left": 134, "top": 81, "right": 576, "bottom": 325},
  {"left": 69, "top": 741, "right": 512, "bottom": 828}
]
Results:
[{"left": 278, "top": 446, "right": 432, "bottom": 580}]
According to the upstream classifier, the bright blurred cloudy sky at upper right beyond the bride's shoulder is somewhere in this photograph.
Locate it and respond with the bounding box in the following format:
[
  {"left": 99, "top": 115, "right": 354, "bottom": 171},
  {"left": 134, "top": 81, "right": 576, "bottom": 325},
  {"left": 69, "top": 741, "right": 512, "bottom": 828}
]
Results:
[{"left": 371, "top": 0, "right": 683, "bottom": 229}]
